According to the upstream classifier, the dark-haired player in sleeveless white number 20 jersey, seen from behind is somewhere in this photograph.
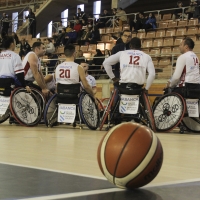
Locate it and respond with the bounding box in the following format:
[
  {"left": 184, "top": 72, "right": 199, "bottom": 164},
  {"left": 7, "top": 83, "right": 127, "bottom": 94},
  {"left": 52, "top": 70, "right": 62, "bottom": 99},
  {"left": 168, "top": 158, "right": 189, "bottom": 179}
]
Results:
[{"left": 55, "top": 45, "right": 94, "bottom": 97}]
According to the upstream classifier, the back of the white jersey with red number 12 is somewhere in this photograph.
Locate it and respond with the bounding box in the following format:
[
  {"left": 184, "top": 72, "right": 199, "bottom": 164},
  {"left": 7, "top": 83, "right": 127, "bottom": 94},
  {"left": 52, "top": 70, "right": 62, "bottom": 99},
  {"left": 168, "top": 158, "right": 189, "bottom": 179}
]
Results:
[{"left": 120, "top": 50, "right": 152, "bottom": 85}]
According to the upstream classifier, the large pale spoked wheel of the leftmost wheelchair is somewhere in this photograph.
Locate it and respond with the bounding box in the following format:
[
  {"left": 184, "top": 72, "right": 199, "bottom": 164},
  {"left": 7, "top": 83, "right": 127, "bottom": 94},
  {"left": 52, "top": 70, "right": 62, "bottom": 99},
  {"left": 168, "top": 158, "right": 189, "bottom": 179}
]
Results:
[{"left": 10, "top": 88, "right": 42, "bottom": 126}]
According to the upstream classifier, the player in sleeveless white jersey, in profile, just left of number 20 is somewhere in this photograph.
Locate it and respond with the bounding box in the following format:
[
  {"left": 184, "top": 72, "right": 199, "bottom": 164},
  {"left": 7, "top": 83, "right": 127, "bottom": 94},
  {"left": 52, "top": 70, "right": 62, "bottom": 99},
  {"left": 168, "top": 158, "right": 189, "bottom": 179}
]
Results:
[{"left": 22, "top": 42, "right": 50, "bottom": 97}]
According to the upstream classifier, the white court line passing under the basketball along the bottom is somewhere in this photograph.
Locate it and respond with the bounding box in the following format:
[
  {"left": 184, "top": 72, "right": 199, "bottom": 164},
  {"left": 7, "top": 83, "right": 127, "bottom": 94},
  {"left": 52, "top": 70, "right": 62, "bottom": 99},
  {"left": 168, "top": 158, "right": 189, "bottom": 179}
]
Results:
[{"left": 19, "top": 179, "right": 200, "bottom": 200}]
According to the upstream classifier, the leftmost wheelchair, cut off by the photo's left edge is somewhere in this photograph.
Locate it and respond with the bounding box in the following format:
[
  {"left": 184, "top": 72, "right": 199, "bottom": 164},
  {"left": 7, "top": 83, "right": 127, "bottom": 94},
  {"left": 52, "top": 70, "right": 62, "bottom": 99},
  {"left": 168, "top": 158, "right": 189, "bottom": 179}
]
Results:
[{"left": 0, "top": 78, "right": 45, "bottom": 126}]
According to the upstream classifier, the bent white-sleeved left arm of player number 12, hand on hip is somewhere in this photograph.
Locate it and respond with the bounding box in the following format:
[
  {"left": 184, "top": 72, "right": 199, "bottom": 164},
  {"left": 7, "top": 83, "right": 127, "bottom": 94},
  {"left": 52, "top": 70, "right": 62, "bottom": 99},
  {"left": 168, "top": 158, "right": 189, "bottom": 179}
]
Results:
[{"left": 103, "top": 52, "right": 121, "bottom": 81}]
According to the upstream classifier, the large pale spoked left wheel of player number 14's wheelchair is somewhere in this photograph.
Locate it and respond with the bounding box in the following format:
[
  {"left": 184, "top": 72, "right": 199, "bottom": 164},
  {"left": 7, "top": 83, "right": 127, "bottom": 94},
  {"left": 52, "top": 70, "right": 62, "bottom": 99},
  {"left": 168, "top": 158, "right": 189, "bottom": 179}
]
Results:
[{"left": 153, "top": 93, "right": 186, "bottom": 132}]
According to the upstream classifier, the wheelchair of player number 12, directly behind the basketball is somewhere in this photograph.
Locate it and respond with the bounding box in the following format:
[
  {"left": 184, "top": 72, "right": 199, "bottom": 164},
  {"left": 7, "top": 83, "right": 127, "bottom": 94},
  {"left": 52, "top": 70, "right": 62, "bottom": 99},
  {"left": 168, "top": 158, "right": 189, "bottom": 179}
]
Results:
[{"left": 100, "top": 83, "right": 155, "bottom": 131}]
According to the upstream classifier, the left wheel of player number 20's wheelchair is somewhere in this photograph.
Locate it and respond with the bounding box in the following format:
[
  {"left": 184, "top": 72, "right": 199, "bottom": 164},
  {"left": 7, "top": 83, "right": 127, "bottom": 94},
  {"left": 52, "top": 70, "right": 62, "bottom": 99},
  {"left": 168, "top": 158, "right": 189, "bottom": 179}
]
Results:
[{"left": 44, "top": 94, "right": 58, "bottom": 127}]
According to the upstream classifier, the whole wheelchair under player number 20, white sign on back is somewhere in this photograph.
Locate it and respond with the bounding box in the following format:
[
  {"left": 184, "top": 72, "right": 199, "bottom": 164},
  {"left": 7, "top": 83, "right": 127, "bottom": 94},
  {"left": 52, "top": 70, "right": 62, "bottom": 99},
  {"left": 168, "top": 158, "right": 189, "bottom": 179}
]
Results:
[{"left": 44, "top": 83, "right": 100, "bottom": 130}]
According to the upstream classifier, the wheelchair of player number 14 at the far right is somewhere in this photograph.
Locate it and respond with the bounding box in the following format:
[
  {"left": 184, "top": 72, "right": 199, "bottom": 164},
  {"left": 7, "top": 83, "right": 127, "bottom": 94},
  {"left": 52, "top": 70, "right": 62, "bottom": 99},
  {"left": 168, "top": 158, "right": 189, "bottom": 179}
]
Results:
[{"left": 153, "top": 83, "right": 200, "bottom": 133}]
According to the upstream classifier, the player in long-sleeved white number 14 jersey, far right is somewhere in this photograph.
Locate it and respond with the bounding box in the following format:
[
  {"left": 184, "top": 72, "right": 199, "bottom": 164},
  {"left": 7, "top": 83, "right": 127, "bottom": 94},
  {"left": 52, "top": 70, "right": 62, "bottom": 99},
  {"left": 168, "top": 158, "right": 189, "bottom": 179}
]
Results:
[{"left": 168, "top": 37, "right": 200, "bottom": 96}]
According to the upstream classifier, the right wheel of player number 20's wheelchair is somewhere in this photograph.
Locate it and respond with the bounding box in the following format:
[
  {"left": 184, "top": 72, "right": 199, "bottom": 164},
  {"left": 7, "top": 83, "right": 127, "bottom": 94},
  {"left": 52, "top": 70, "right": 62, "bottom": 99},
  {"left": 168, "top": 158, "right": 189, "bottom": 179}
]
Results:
[{"left": 79, "top": 93, "right": 100, "bottom": 130}]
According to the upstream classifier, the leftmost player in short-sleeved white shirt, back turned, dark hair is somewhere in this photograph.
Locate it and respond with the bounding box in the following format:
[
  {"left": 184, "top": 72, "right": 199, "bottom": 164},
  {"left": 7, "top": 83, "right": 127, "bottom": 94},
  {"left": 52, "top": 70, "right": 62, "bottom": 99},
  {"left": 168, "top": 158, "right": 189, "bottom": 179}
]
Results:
[{"left": 0, "top": 36, "right": 29, "bottom": 90}]
